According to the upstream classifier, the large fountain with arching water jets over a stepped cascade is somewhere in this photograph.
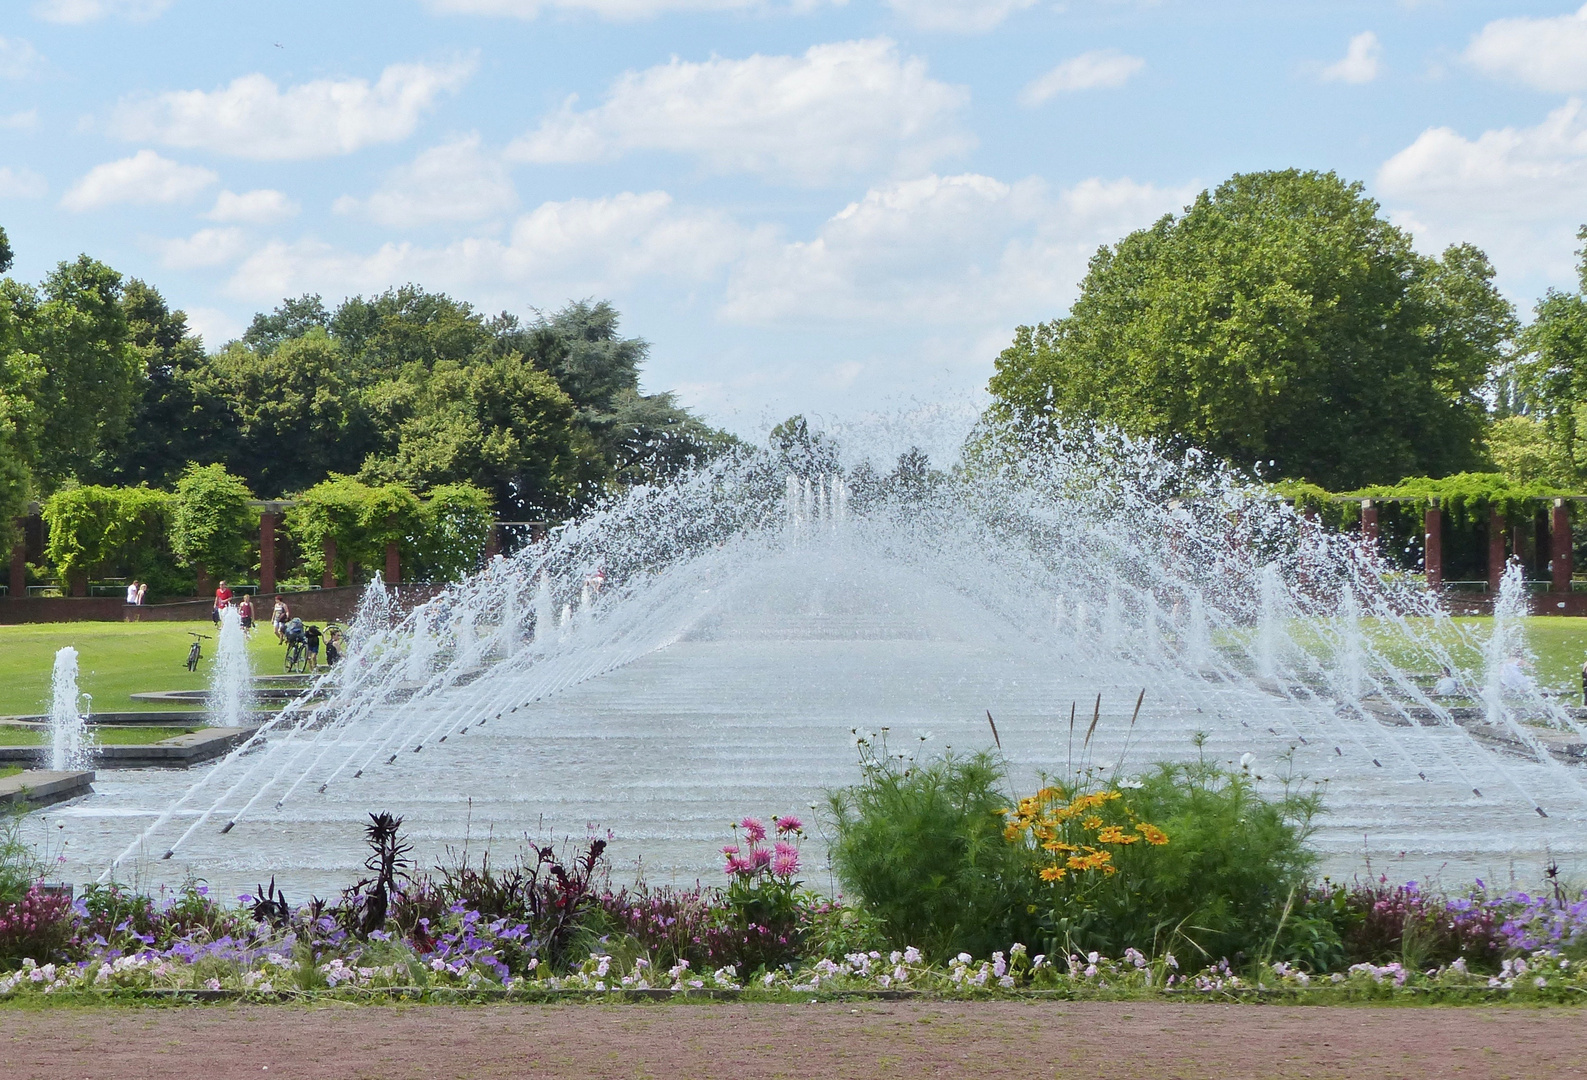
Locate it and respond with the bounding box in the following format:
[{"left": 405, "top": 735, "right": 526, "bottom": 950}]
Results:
[{"left": 30, "top": 428, "right": 1587, "bottom": 894}]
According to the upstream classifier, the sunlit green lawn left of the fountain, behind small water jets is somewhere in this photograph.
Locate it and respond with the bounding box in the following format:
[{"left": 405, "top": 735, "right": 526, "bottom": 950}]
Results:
[{"left": 0, "top": 622, "right": 284, "bottom": 717}]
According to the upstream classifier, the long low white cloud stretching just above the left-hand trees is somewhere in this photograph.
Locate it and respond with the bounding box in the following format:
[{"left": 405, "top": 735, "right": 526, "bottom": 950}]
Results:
[{"left": 227, "top": 192, "right": 744, "bottom": 306}]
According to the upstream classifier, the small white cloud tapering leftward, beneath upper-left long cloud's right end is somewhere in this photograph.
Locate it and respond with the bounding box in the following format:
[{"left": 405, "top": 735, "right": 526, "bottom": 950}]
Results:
[{"left": 335, "top": 135, "right": 517, "bottom": 227}]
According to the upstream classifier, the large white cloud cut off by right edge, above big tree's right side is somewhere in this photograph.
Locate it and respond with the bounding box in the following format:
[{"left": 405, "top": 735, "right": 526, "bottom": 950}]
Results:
[{"left": 1378, "top": 100, "right": 1587, "bottom": 281}]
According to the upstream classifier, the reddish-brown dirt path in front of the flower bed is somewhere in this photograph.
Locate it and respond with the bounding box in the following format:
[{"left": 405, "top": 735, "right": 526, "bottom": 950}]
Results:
[{"left": 0, "top": 1002, "right": 1587, "bottom": 1080}]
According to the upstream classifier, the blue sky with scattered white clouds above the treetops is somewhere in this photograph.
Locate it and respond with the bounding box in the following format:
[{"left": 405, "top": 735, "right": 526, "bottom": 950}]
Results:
[{"left": 0, "top": 0, "right": 1587, "bottom": 433}]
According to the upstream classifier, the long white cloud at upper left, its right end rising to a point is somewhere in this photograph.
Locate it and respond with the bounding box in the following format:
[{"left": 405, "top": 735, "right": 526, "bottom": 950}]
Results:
[{"left": 111, "top": 60, "right": 475, "bottom": 160}]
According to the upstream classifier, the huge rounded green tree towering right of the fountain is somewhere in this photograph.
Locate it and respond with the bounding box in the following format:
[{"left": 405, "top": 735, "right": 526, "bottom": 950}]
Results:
[{"left": 990, "top": 170, "right": 1514, "bottom": 490}]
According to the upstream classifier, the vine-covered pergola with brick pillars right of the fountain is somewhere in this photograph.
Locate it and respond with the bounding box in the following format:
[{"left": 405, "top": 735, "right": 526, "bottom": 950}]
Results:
[{"left": 1279, "top": 473, "right": 1587, "bottom": 593}]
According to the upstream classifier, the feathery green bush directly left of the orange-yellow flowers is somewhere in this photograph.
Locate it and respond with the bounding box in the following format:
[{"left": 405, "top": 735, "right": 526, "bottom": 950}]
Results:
[{"left": 828, "top": 742, "right": 1038, "bottom": 956}]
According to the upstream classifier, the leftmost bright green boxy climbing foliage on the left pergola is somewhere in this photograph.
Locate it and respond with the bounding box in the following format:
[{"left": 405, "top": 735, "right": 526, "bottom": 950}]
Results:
[{"left": 43, "top": 487, "right": 175, "bottom": 582}]
